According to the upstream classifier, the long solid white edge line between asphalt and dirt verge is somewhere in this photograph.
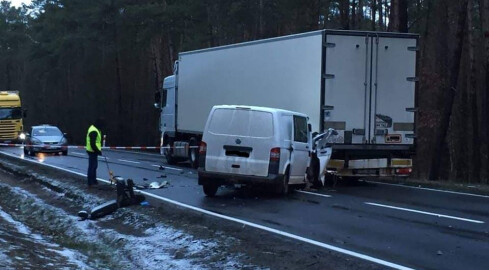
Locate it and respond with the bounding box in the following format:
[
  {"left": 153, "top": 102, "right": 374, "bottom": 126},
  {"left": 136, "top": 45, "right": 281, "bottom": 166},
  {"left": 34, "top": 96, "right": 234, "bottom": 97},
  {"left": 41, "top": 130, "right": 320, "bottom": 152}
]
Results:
[{"left": 2, "top": 152, "right": 413, "bottom": 270}]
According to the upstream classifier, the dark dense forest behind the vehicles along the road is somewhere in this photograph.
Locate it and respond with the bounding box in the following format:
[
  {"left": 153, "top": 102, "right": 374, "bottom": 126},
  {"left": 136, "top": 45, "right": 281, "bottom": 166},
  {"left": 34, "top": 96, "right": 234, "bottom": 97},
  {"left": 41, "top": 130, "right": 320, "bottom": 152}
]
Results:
[{"left": 0, "top": 0, "right": 489, "bottom": 183}]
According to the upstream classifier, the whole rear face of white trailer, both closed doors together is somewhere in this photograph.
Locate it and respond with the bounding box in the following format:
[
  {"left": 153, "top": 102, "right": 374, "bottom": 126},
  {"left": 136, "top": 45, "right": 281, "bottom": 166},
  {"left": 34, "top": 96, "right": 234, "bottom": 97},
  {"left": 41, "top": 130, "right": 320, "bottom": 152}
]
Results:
[{"left": 323, "top": 32, "right": 417, "bottom": 145}]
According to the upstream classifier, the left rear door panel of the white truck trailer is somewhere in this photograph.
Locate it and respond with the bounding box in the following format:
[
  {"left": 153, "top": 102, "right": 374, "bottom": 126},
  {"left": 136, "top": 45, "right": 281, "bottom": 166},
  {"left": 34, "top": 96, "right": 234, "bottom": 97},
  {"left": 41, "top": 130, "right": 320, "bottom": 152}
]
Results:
[{"left": 323, "top": 35, "right": 371, "bottom": 144}]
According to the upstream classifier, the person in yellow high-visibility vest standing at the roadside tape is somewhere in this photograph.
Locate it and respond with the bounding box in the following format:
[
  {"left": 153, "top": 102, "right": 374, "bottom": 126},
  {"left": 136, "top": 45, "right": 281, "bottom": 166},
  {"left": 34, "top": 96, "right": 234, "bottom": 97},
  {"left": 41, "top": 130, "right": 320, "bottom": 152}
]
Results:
[{"left": 85, "top": 118, "right": 105, "bottom": 187}]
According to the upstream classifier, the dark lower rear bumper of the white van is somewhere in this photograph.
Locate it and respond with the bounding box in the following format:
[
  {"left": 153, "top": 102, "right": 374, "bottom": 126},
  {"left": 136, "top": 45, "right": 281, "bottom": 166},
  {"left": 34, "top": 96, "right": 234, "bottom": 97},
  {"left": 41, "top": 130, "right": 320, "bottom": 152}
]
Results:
[{"left": 199, "top": 168, "right": 284, "bottom": 186}]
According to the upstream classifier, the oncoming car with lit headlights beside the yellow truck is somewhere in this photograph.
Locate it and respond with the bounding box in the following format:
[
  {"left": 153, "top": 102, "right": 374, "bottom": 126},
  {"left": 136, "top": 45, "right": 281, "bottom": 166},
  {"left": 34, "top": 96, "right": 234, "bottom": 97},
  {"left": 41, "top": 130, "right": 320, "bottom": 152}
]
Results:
[{"left": 24, "top": 125, "right": 68, "bottom": 156}]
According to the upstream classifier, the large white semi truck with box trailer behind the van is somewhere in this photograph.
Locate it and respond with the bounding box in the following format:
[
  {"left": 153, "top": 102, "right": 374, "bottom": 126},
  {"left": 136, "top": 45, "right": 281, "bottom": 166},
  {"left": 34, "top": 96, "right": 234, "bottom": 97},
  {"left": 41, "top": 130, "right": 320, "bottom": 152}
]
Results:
[{"left": 156, "top": 30, "right": 418, "bottom": 180}]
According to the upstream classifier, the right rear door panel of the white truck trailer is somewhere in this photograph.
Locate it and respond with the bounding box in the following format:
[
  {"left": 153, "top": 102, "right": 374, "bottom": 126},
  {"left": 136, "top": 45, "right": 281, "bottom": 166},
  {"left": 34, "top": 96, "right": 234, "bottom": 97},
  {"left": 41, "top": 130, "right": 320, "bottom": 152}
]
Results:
[{"left": 370, "top": 37, "right": 416, "bottom": 144}]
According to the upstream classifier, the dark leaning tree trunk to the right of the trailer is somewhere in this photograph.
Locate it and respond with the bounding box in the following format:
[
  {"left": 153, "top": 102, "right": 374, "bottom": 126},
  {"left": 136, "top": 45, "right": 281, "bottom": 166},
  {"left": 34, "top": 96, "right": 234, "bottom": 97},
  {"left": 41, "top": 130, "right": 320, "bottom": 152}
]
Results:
[{"left": 429, "top": 0, "right": 468, "bottom": 180}]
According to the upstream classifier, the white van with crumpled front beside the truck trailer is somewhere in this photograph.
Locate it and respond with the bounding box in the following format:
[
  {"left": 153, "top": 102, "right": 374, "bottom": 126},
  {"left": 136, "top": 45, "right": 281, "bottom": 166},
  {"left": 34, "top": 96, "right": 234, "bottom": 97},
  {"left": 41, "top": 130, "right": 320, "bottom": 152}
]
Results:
[{"left": 199, "top": 105, "right": 311, "bottom": 197}]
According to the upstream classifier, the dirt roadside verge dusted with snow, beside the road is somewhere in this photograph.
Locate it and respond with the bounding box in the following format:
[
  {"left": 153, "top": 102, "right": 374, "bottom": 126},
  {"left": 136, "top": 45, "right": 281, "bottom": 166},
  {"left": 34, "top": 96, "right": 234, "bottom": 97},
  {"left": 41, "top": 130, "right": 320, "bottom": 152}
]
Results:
[{"left": 0, "top": 156, "right": 383, "bottom": 269}]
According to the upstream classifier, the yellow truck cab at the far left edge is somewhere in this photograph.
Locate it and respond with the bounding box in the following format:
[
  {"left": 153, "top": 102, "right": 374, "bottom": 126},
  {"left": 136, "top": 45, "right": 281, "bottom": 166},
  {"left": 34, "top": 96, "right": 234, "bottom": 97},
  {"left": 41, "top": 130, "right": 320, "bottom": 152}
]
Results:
[{"left": 0, "top": 91, "right": 24, "bottom": 142}]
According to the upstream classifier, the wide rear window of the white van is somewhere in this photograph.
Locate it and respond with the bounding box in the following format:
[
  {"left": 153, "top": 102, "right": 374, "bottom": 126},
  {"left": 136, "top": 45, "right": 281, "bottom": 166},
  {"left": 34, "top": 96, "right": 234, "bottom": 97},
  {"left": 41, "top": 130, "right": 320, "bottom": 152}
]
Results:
[{"left": 209, "top": 109, "right": 273, "bottom": 138}]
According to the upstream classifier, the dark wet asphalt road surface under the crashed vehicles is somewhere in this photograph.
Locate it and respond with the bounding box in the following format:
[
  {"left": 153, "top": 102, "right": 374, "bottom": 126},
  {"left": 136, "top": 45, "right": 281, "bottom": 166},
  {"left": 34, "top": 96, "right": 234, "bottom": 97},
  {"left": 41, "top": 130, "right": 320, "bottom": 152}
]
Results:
[{"left": 0, "top": 148, "right": 489, "bottom": 269}]
